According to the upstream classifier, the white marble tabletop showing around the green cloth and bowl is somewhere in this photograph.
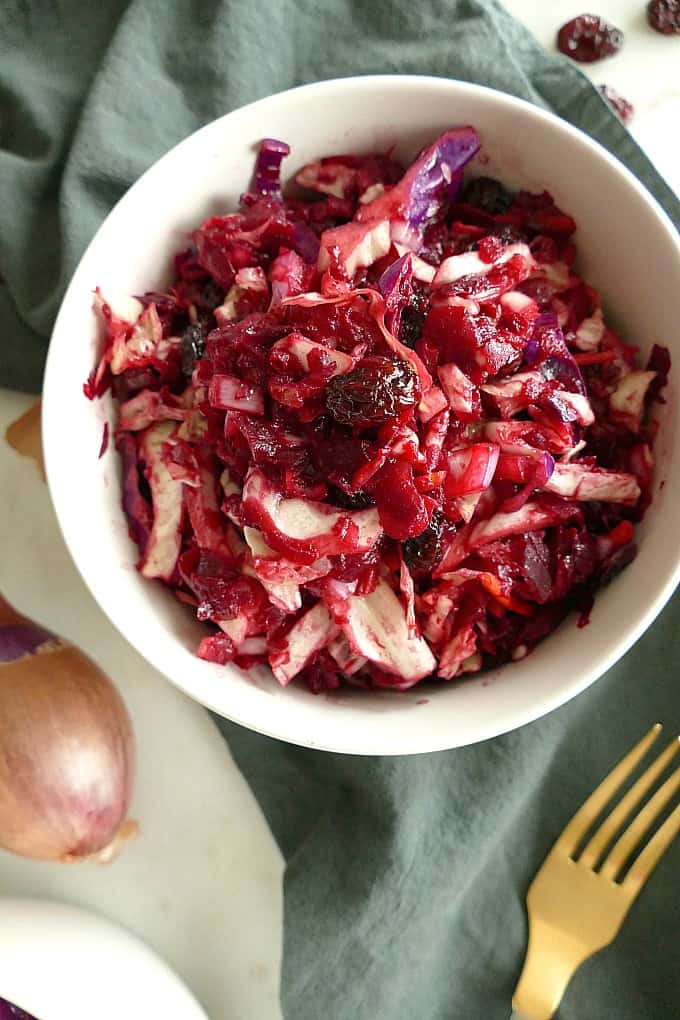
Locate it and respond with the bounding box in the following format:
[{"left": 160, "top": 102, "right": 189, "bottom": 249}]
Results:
[{"left": 0, "top": 7, "right": 680, "bottom": 1020}]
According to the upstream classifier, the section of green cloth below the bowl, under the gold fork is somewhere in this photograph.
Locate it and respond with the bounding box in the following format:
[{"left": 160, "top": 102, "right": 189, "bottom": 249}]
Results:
[{"left": 223, "top": 598, "right": 680, "bottom": 1020}]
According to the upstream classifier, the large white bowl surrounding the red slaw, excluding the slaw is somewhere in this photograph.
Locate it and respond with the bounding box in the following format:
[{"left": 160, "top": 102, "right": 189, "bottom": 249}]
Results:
[{"left": 43, "top": 77, "right": 680, "bottom": 755}]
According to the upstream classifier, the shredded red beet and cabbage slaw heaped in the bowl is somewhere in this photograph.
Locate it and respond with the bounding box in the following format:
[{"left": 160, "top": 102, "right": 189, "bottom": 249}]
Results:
[{"left": 85, "top": 126, "right": 670, "bottom": 693}]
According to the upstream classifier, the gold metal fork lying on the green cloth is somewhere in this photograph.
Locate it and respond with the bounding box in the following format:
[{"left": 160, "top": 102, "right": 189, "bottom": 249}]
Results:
[{"left": 511, "top": 723, "right": 680, "bottom": 1020}]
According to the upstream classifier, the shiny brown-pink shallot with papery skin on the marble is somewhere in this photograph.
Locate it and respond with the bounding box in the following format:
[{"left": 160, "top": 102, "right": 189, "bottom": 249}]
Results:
[{"left": 0, "top": 596, "right": 135, "bottom": 861}]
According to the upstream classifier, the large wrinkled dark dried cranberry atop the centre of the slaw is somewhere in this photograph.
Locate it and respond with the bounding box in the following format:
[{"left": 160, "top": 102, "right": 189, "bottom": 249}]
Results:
[{"left": 326, "top": 356, "right": 419, "bottom": 428}]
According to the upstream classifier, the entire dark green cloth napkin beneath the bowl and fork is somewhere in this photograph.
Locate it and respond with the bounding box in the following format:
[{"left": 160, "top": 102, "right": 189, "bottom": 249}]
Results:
[{"left": 0, "top": 0, "right": 680, "bottom": 1020}]
